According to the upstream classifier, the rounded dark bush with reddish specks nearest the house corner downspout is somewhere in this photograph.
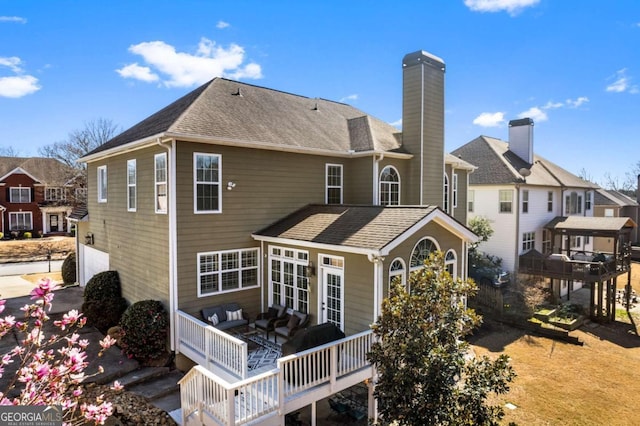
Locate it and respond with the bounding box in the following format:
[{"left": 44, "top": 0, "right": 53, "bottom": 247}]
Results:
[{"left": 120, "top": 300, "right": 169, "bottom": 362}]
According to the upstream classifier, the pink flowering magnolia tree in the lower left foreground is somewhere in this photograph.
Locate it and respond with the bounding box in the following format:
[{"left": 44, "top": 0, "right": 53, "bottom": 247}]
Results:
[{"left": 0, "top": 278, "right": 122, "bottom": 425}]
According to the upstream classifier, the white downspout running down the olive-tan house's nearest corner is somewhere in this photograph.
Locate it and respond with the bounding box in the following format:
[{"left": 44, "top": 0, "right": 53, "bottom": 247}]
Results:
[{"left": 156, "top": 138, "right": 178, "bottom": 351}]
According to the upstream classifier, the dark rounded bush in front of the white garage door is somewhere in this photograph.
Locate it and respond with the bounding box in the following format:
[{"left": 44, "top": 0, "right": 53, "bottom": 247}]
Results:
[{"left": 82, "top": 271, "right": 127, "bottom": 334}]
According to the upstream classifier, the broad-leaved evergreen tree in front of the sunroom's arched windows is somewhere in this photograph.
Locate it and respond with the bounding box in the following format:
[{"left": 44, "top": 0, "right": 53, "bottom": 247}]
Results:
[{"left": 368, "top": 252, "right": 515, "bottom": 425}]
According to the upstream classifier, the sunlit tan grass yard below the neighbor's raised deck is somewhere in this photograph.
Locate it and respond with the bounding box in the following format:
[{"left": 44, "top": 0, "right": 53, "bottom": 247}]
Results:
[{"left": 470, "top": 263, "right": 640, "bottom": 426}]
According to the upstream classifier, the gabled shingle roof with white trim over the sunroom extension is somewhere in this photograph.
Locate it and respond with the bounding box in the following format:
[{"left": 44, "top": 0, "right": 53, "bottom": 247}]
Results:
[{"left": 253, "top": 204, "right": 475, "bottom": 255}]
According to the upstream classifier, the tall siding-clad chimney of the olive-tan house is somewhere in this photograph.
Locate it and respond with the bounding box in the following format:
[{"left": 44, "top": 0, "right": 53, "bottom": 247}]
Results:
[{"left": 402, "top": 50, "right": 445, "bottom": 207}]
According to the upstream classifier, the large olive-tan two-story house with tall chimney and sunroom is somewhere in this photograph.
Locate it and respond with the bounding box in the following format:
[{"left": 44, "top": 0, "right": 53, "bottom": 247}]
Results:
[{"left": 77, "top": 51, "right": 476, "bottom": 422}]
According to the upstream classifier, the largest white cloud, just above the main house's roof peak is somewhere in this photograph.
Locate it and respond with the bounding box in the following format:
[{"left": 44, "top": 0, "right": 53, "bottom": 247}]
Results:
[{"left": 116, "top": 37, "right": 262, "bottom": 87}]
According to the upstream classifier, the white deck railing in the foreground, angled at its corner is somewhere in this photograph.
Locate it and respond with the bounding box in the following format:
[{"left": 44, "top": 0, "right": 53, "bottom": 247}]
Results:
[{"left": 180, "top": 331, "right": 374, "bottom": 425}]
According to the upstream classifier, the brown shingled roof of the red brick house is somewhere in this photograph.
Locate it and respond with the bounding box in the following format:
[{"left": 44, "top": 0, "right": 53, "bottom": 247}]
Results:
[{"left": 0, "top": 157, "right": 73, "bottom": 186}]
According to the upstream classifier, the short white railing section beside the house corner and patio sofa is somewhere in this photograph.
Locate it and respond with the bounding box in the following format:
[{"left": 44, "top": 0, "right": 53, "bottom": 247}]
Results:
[{"left": 176, "top": 311, "right": 249, "bottom": 378}]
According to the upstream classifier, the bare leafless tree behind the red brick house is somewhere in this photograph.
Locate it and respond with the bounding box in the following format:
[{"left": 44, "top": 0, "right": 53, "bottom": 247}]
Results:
[{"left": 38, "top": 118, "right": 120, "bottom": 169}]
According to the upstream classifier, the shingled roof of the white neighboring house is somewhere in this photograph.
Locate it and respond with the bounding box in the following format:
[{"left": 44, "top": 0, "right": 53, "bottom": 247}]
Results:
[{"left": 451, "top": 136, "right": 598, "bottom": 188}]
